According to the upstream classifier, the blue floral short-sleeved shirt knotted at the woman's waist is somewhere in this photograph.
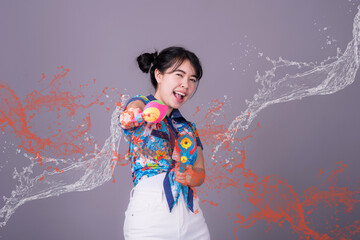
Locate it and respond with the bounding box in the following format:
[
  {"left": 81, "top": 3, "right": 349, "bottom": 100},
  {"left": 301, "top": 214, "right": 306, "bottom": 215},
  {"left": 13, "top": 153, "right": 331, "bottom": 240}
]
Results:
[{"left": 124, "top": 95, "right": 202, "bottom": 210}]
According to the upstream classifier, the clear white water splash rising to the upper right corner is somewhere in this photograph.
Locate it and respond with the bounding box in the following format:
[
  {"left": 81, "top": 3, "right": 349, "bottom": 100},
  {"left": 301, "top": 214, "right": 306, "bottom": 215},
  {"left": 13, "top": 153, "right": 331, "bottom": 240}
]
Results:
[{"left": 212, "top": 7, "right": 360, "bottom": 160}]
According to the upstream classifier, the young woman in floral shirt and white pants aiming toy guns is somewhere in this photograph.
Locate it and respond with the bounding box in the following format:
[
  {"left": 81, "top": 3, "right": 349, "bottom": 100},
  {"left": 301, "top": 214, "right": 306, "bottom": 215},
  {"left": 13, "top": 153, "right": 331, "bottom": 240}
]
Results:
[{"left": 120, "top": 47, "right": 210, "bottom": 240}]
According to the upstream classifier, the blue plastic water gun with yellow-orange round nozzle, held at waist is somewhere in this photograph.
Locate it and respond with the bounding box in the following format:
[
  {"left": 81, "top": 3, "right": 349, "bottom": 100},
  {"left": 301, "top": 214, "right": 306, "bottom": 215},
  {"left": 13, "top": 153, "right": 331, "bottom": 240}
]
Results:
[{"left": 174, "top": 133, "right": 197, "bottom": 173}]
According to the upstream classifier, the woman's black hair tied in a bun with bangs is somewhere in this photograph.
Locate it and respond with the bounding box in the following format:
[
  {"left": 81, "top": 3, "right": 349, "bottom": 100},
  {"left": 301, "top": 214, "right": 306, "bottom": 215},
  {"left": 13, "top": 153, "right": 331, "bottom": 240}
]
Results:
[{"left": 136, "top": 46, "right": 203, "bottom": 90}]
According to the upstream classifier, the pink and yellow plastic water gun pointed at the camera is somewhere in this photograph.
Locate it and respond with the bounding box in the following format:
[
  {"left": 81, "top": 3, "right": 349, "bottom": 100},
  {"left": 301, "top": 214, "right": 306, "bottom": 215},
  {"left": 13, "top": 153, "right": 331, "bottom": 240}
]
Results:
[{"left": 132, "top": 100, "right": 168, "bottom": 123}]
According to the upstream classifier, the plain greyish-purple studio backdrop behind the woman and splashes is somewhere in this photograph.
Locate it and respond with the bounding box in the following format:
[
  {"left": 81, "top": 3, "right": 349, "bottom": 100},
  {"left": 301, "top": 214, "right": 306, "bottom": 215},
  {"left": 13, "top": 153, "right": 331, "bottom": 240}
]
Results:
[{"left": 0, "top": 0, "right": 360, "bottom": 240}]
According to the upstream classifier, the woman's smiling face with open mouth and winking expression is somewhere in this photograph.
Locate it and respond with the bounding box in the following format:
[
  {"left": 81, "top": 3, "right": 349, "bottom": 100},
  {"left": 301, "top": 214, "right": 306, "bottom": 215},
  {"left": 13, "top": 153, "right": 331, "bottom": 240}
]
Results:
[{"left": 155, "top": 60, "right": 197, "bottom": 114}]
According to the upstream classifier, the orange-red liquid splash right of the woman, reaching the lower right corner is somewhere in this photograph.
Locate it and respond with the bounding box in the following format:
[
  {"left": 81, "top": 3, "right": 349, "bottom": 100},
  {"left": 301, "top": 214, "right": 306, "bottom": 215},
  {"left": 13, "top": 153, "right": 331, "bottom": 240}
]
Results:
[{"left": 197, "top": 101, "right": 360, "bottom": 240}]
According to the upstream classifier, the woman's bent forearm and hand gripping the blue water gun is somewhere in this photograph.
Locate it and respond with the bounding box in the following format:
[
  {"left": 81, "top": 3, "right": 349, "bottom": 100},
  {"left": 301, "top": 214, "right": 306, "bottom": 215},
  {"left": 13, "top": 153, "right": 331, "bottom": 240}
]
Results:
[{"left": 175, "top": 147, "right": 205, "bottom": 187}]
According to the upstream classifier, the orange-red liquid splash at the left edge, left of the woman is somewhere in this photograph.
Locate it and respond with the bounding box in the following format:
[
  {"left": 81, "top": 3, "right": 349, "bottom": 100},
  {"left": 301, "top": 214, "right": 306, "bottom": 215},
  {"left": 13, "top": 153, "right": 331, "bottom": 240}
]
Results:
[{"left": 0, "top": 66, "right": 122, "bottom": 180}]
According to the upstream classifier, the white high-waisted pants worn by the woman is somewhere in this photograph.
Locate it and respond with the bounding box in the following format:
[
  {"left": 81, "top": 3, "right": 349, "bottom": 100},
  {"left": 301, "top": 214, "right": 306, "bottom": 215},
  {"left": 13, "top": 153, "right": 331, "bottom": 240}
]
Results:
[{"left": 124, "top": 174, "right": 210, "bottom": 240}]
